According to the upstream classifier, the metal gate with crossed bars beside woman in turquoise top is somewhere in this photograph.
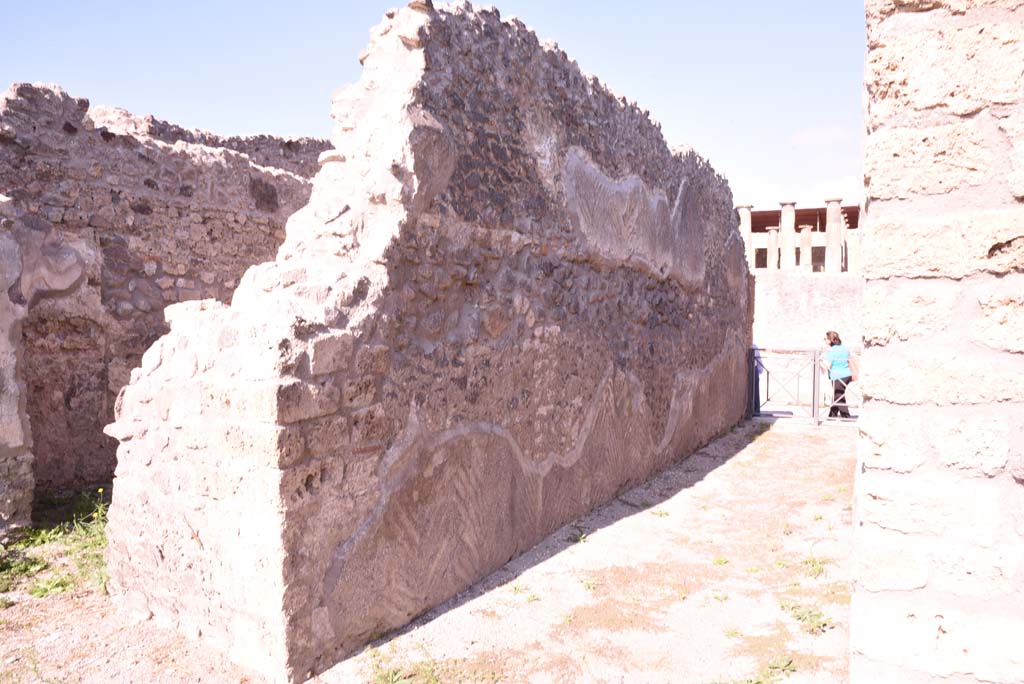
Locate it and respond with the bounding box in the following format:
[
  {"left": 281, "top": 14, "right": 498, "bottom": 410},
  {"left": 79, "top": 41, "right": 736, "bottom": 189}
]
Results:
[{"left": 748, "top": 347, "right": 860, "bottom": 425}]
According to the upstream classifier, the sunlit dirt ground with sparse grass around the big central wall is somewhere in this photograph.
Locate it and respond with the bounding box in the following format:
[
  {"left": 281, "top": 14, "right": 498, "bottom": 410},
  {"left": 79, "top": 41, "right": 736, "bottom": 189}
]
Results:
[{"left": 0, "top": 422, "right": 856, "bottom": 684}]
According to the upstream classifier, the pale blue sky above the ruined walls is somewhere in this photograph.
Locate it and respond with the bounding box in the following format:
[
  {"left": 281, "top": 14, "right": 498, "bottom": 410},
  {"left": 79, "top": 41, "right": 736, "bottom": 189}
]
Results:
[{"left": 0, "top": 0, "right": 865, "bottom": 209}]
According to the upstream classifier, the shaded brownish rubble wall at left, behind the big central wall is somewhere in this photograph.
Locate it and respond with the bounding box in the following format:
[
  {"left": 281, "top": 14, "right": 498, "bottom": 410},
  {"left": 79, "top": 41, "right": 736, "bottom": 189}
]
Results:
[{"left": 0, "top": 84, "right": 319, "bottom": 491}]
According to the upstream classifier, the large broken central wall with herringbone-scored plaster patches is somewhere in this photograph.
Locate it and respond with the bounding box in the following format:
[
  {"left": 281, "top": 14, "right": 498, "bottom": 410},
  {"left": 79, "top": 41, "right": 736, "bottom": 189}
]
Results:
[{"left": 108, "top": 0, "right": 751, "bottom": 681}]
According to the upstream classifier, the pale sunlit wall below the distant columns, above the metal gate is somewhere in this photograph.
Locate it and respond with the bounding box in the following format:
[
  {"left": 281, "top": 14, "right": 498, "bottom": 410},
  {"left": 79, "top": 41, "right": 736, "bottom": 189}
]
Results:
[{"left": 754, "top": 270, "right": 864, "bottom": 349}]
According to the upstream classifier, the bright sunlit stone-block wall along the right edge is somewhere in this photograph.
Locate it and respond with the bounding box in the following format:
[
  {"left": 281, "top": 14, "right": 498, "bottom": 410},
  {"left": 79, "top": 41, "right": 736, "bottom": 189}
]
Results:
[{"left": 851, "top": 0, "right": 1024, "bottom": 684}]
